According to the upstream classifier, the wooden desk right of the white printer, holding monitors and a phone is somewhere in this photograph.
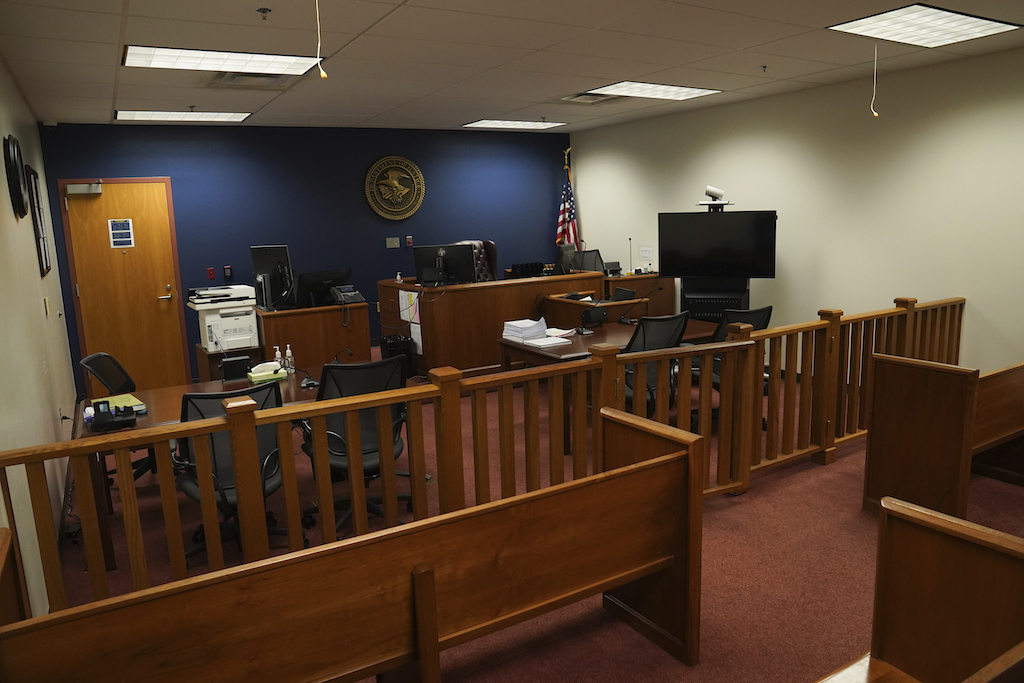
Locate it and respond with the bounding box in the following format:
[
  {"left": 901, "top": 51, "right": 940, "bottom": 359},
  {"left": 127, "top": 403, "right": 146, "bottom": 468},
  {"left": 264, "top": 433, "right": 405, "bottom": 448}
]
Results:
[{"left": 256, "top": 303, "right": 371, "bottom": 370}]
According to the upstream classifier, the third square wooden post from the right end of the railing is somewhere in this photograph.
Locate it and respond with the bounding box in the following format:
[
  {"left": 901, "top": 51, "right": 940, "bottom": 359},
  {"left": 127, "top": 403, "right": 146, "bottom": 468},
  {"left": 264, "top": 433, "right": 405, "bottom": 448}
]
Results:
[{"left": 726, "top": 323, "right": 764, "bottom": 495}]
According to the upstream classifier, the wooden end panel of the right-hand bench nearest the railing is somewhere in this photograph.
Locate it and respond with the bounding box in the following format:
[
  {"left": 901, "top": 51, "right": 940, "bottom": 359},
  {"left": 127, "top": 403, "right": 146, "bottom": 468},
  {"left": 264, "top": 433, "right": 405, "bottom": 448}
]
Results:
[{"left": 864, "top": 353, "right": 978, "bottom": 517}]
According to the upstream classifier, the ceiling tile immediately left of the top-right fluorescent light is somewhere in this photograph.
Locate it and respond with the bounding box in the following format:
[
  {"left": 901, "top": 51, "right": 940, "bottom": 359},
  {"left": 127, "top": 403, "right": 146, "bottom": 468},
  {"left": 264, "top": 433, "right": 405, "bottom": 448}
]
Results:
[{"left": 605, "top": 3, "right": 807, "bottom": 48}]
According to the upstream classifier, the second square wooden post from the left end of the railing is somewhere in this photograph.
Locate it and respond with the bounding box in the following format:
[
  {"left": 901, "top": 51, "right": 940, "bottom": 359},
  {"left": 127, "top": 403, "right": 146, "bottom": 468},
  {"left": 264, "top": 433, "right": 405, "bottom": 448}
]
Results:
[{"left": 428, "top": 367, "right": 466, "bottom": 513}]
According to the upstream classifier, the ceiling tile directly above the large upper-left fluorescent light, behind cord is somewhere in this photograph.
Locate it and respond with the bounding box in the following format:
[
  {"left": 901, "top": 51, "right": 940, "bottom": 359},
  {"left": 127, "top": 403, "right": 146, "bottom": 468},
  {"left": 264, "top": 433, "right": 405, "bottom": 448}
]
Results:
[{"left": 125, "top": 16, "right": 355, "bottom": 56}]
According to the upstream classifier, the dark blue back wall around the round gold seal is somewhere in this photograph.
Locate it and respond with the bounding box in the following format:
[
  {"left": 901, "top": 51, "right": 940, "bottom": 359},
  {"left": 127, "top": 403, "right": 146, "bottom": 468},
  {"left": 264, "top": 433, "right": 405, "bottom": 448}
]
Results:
[{"left": 40, "top": 124, "right": 568, "bottom": 387}]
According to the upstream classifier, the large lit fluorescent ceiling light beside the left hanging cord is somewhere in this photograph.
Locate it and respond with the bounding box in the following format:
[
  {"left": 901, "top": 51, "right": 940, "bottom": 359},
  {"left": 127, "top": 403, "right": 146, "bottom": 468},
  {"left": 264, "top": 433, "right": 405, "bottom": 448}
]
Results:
[{"left": 124, "top": 45, "right": 316, "bottom": 76}]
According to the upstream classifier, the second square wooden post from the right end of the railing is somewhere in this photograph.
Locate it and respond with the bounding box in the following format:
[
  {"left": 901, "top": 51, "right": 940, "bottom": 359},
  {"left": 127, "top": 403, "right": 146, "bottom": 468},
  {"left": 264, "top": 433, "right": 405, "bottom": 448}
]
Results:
[{"left": 811, "top": 308, "right": 845, "bottom": 465}]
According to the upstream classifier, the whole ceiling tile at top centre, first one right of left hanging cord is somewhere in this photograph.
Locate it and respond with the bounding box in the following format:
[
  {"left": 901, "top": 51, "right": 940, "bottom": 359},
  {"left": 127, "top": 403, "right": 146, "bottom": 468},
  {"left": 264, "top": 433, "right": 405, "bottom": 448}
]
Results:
[{"left": 368, "top": 6, "right": 587, "bottom": 50}]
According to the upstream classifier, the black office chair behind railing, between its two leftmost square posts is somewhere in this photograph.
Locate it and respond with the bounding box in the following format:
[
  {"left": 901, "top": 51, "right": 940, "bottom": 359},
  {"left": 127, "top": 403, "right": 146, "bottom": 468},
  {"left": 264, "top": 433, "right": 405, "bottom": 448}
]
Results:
[{"left": 302, "top": 355, "right": 413, "bottom": 532}]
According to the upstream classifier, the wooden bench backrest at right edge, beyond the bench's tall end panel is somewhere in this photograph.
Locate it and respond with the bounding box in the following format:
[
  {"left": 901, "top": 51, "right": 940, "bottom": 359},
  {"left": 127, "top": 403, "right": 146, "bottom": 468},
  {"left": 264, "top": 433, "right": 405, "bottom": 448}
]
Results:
[{"left": 971, "top": 364, "right": 1024, "bottom": 453}]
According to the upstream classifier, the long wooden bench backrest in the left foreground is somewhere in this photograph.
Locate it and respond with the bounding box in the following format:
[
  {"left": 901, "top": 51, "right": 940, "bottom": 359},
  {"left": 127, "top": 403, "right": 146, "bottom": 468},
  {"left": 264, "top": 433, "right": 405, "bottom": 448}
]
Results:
[{"left": 0, "top": 409, "right": 700, "bottom": 683}]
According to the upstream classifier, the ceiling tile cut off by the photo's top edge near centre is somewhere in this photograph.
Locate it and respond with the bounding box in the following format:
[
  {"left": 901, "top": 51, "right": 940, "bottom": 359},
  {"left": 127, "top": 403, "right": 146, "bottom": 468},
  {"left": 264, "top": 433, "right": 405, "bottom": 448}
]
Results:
[{"left": 409, "top": 0, "right": 663, "bottom": 28}]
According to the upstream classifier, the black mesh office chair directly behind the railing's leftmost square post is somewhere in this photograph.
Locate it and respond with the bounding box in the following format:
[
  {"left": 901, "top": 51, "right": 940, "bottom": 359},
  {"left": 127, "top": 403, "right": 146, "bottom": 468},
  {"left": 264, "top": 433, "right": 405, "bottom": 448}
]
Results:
[{"left": 174, "top": 382, "right": 288, "bottom": 557}]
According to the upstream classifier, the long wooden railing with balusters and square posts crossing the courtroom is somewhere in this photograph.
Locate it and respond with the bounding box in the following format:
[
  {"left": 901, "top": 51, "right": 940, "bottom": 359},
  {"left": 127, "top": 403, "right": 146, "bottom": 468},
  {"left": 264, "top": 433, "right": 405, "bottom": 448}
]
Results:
[{"left": 0, "top": 299, "right": 964, "bottom": 611}]
